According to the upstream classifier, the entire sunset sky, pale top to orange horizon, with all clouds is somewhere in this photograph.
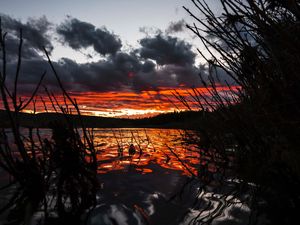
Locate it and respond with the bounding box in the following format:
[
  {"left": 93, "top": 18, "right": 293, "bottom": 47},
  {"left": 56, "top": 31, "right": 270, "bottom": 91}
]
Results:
[{"left": 0, "top": 0, "right": 232, "bottom": 117}]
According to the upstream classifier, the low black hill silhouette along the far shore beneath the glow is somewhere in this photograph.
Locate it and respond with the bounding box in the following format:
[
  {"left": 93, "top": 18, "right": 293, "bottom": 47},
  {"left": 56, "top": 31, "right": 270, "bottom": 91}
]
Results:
[{"left": 0, "top": 110, "right": 202, "bottom": 129}]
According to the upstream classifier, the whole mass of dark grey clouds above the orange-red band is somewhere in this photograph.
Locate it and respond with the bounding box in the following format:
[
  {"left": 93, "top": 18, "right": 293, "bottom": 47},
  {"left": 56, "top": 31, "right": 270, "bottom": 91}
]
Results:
[{"left": 0, "top": 14, "right": 220, "bottom": 94}]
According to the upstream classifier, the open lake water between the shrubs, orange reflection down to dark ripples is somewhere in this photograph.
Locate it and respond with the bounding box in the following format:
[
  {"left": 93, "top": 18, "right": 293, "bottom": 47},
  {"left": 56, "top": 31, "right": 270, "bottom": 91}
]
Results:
[{"left": 0, "top": 128, "right": 249, "bottom": 225}]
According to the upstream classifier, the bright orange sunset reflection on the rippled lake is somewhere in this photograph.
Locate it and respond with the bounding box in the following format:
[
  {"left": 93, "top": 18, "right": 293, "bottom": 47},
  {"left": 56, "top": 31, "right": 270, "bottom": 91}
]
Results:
[{"left": 95, "top": 128, "right": 199, "bottom": 176}]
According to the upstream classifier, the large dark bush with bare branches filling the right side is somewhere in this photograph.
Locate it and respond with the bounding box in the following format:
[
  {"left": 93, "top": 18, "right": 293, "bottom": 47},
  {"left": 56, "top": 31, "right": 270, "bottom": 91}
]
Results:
[{"left": 180, "top": 0, "right": 300, "bottom": 224}]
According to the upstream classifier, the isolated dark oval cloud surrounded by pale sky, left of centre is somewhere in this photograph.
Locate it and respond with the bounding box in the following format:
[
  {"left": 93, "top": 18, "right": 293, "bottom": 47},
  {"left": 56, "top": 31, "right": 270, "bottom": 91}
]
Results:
[{"left": 57, "top": 18, "right": 122, "bottom": 55}]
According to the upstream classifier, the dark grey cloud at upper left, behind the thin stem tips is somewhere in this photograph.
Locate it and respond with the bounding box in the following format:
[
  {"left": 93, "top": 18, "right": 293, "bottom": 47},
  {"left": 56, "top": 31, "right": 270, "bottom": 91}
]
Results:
[{"left": 0, "top": 14, "right": 53, "bottom": 52}]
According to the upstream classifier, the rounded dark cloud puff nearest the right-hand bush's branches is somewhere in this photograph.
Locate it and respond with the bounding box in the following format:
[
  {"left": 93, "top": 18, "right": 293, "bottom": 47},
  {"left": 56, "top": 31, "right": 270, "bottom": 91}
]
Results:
[{"left": 140, "top": 34, "right": 196, "bottom": 65}]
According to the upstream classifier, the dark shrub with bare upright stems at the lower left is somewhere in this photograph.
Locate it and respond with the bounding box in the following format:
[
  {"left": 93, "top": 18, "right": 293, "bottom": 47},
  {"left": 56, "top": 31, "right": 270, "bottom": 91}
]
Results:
[{"left": 0, "top": 20, "right": 98, "bottom": 224}]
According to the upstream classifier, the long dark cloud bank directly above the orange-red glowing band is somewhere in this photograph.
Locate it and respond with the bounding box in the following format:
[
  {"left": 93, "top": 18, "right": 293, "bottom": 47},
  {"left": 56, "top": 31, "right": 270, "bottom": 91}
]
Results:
[{"left": 3, "top": 52, "right": 201, "bottom": 94}]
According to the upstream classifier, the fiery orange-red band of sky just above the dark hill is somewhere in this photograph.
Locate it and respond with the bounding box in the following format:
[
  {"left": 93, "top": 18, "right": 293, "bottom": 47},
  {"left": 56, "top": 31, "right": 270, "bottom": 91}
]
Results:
[{"left": 0, "top": 86, "right": 238, "bottom": 118}]
